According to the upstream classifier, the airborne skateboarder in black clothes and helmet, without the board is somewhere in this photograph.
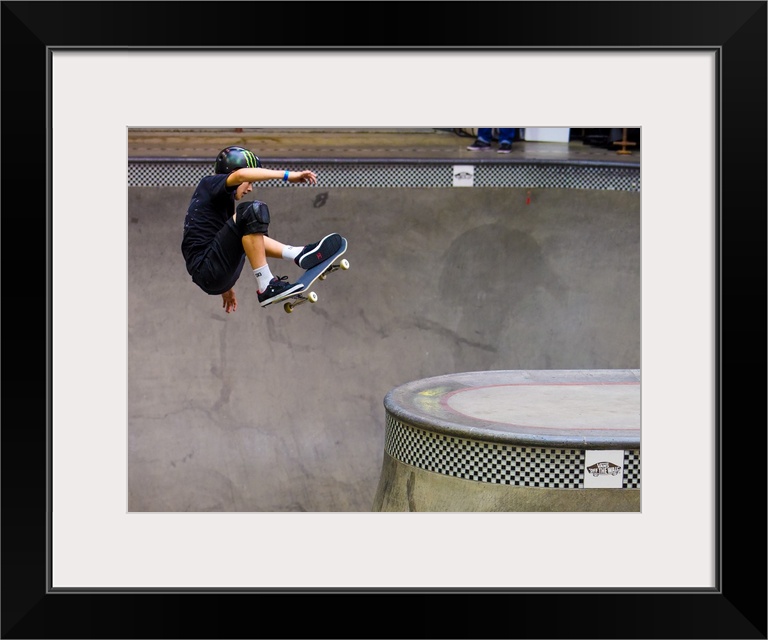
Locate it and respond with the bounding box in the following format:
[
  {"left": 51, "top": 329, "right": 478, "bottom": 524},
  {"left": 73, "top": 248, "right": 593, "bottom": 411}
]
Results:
[{"left": 181, "top": 147, "right": 341, "bottom": 313}]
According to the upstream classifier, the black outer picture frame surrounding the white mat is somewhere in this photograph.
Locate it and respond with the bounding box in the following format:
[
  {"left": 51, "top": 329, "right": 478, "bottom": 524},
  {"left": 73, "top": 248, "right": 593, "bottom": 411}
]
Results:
[{"left": 0, "top": 1, "right": 767, "bottom": 638}]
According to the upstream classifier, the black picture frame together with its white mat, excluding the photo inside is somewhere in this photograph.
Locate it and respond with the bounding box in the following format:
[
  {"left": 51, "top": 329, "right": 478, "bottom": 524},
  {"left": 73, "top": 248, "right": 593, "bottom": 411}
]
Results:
[{"left": 1, "top": 2, "right": 766, "bottom": 638}]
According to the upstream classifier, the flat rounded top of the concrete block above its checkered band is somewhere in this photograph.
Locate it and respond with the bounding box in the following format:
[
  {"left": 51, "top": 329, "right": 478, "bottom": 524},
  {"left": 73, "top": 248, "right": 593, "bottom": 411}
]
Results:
[{"left": 384, "top": 369, "right": 640, "bottom": 449}]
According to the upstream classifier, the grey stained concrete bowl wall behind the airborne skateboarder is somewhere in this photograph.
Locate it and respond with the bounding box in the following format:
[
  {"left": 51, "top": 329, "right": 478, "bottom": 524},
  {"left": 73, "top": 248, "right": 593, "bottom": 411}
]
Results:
[{"left": 127, "top": 186, "right": 641, "bottom": 512}]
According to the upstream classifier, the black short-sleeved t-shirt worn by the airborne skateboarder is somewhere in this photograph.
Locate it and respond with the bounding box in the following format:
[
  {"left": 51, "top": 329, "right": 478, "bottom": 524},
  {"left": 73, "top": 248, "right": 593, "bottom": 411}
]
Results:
[{"left": 181, "top": 173, "right": 237, "bottom": 265}]
